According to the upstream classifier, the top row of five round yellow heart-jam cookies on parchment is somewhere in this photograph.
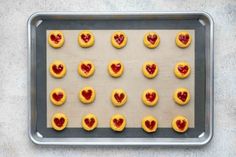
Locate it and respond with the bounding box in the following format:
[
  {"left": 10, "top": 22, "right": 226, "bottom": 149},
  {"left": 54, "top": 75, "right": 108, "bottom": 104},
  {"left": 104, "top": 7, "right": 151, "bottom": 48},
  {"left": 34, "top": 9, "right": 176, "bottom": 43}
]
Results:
[{"left": 48, "top": 30, "right": 192, "bottom": 49}]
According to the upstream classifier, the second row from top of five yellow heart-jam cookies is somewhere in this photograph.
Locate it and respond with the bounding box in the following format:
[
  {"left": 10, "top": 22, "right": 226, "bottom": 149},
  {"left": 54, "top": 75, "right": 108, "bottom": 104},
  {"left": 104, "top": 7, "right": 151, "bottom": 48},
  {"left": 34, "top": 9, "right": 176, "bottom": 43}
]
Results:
[{"left": 49, "top": 60, "right": 191, "bottom": 79}]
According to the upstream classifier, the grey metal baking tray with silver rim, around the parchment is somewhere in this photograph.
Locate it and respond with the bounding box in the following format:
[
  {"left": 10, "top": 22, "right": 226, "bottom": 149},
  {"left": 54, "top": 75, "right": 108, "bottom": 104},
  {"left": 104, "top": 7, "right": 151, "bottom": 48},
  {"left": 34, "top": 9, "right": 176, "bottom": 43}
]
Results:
[{"left": 27, "top": 12, "right": 214, "bottom": 146}]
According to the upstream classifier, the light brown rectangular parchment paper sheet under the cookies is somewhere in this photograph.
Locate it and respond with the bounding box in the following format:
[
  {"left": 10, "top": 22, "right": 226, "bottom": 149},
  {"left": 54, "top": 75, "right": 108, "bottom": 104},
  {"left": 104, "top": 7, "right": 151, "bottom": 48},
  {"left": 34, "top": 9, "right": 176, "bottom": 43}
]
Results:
[{"left": 46, "top": 30, "right": 195, "bottom": 128}]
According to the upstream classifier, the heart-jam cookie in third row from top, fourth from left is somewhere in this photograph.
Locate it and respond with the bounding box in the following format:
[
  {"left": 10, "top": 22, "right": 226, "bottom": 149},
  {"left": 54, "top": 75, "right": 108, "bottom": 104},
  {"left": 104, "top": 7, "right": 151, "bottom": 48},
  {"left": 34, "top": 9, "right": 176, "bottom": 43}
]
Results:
[{"left": 142, "top": 89, "right": 159, "bottom": 106}]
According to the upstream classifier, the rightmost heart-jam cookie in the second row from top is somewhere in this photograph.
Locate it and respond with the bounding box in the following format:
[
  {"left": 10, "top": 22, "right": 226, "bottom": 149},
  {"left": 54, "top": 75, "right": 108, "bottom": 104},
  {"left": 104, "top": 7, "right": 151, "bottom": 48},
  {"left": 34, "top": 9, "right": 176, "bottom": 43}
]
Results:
[{"left": 174, "top": 62, "right": 191, "bottom": 79}]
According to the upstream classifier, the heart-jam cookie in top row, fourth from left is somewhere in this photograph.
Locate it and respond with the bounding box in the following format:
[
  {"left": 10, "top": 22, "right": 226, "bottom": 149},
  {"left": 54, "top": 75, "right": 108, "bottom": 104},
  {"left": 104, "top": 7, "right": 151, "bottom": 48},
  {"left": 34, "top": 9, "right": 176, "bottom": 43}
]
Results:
[{"left": 143, "top": 32, "right": 160, "bottom": 49}]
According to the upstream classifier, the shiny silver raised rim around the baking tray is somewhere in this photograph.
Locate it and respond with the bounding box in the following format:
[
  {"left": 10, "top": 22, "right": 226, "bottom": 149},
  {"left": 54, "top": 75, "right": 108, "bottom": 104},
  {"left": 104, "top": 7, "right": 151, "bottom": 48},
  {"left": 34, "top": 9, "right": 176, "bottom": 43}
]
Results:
[{"left": 27, "top": 11, "right": 214, "bottom": 146}]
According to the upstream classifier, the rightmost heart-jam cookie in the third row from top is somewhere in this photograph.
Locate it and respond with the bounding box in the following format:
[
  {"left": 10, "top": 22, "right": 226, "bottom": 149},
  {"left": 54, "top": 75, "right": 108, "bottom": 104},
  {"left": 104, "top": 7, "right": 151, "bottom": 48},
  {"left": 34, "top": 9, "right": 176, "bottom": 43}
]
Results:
[{"left": 173, "top": 88, "right": 190, "bottom": 105}]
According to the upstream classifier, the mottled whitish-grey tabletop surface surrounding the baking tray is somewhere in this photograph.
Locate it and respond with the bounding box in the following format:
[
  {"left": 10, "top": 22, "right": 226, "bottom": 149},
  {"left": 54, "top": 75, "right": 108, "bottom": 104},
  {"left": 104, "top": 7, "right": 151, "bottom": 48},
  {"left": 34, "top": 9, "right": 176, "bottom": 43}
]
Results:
[{"left": 0, "top": 0, "right": 236, "bottom": 157}]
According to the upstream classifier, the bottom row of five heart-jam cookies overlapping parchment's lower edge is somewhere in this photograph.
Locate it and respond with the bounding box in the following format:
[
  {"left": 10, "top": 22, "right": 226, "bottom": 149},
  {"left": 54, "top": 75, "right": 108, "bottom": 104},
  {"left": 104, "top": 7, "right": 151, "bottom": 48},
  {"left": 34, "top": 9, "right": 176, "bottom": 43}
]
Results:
[{"left": 51, "top": 113, "right": 189, "bottom": 133}]
